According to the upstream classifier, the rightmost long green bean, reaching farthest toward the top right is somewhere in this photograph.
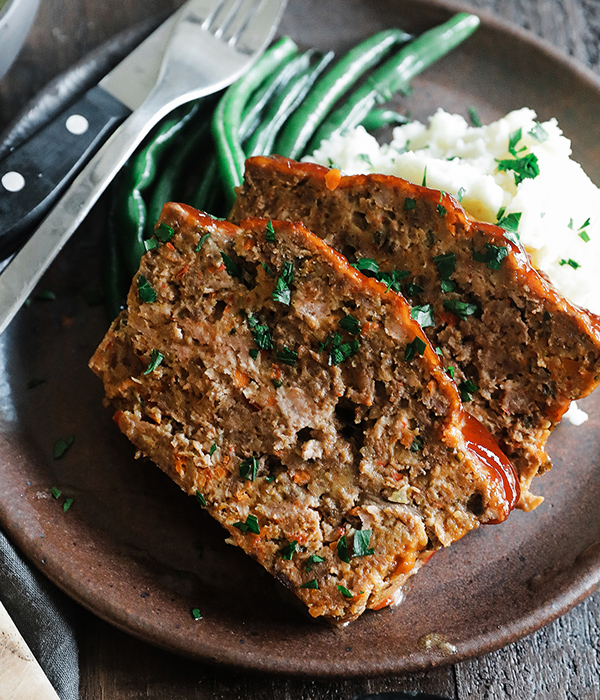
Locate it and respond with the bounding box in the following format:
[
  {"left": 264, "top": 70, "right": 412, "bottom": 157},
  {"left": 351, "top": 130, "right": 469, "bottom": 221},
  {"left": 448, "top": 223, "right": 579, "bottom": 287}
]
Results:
[{"left": 309, "top": 12, "right": 479, "bottom": 151}]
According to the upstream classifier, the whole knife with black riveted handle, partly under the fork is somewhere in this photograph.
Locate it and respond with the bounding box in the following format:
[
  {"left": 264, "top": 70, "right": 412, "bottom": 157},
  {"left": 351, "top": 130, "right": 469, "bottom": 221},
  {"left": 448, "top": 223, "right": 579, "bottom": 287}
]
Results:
[{"left": 0, "top": 11, "right": 179, "bottom": 260}]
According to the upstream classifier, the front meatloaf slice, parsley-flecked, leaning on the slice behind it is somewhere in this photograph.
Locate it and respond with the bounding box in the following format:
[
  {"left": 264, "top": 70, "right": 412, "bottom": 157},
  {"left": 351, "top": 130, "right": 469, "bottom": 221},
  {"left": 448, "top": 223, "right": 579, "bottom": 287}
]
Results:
[{"left": 91, "top": 204, "right": 518, "bottom": 623}]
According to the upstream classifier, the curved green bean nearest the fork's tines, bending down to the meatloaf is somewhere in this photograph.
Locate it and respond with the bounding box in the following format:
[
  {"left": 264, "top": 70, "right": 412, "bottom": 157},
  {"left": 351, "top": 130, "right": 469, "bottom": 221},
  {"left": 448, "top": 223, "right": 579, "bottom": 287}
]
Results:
[{"left": 212, "top": 37, "right": 298, "bottom": 208}]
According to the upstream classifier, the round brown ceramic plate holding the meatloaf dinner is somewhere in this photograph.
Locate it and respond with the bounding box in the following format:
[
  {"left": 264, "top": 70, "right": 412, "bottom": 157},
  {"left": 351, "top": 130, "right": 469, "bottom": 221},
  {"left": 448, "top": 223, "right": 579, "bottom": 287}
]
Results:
[{"left": 0, "top": 0, "right": 600, "bottom": 677}]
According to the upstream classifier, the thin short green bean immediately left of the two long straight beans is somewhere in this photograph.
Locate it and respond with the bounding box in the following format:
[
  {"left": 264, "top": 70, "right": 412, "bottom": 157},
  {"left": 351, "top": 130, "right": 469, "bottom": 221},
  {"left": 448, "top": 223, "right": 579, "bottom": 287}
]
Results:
[{"left": 246, "top": 51, "right": 334, "bottom": 156}]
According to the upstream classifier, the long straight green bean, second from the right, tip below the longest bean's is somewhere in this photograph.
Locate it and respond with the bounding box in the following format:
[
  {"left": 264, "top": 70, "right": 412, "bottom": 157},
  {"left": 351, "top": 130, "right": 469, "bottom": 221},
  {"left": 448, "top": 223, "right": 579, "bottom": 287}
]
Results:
[{"left": 275, "top": 29, "right": 411, "bottom": 158}]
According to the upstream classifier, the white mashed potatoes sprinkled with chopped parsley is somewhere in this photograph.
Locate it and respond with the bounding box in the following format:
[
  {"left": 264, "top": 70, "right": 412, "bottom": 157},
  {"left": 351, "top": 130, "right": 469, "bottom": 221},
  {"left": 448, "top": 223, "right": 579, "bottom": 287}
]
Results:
[{"left": 308, "top": 109, "right": 600, "bottom": 314}]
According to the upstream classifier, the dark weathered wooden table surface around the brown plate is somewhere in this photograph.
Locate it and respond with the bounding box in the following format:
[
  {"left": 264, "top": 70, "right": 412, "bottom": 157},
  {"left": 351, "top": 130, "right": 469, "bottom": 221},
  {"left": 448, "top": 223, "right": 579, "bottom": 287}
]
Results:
[{"left": 0, "top": 0, "right": 600, "bottom": 700}]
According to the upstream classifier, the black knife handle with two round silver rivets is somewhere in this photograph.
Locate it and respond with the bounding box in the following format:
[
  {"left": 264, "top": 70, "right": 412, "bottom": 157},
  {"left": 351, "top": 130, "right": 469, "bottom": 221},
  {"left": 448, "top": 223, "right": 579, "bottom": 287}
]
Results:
[{"left": 0, "top": 86, "right": 130, "bottom": 259}]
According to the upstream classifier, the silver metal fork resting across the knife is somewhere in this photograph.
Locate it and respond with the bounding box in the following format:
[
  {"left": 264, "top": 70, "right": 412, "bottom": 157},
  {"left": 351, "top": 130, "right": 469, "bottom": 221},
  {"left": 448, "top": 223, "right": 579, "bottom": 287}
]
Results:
[{"left": 0, "top": 0, "right": 287, "bottom": 333}]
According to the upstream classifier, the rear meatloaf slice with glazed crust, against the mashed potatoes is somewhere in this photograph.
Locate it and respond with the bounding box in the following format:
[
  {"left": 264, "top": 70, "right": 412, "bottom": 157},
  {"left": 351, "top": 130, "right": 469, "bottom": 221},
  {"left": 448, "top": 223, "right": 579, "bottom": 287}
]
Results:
[{"left": 231, "top": 157, "right": 600, "bottom": 510}]
